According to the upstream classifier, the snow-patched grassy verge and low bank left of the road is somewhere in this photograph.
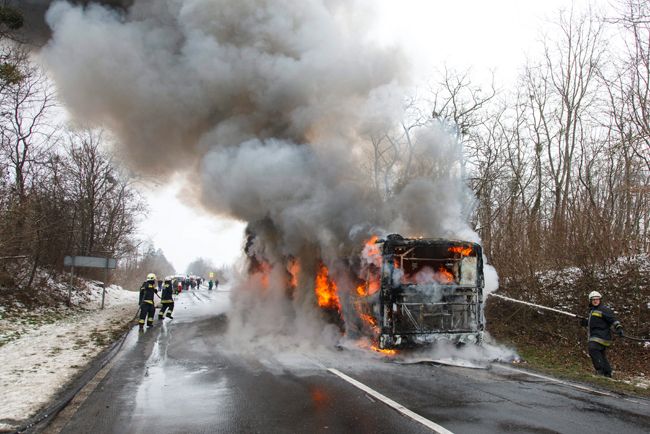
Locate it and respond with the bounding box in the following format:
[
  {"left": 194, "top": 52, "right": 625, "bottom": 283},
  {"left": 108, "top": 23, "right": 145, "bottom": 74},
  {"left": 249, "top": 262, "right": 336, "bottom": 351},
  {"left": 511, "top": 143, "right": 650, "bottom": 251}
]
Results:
[{"left": 0, "top": 276, "right": 138, "bottom": 430}]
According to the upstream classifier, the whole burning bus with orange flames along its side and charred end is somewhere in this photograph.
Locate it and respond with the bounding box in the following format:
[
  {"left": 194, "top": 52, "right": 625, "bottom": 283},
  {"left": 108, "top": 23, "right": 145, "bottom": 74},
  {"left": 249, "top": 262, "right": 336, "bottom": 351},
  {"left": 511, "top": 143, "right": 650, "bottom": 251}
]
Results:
[{"left": 245, "top": 229, "right": 484, "bottom": 352}]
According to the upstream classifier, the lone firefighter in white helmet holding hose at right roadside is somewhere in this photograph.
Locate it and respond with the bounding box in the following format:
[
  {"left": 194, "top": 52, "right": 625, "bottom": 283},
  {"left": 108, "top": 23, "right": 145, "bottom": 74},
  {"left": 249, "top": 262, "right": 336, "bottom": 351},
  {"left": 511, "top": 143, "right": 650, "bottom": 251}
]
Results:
[{"left": 581, "top": 291, "right": 623, "bottom": 377}]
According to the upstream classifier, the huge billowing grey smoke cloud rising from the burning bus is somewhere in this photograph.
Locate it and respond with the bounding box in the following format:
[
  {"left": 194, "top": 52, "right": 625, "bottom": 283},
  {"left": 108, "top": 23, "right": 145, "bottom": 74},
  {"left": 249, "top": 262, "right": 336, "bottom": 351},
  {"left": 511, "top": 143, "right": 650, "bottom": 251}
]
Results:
[{"left": 43, "top": 0, "right": 486, "bottom": 350}]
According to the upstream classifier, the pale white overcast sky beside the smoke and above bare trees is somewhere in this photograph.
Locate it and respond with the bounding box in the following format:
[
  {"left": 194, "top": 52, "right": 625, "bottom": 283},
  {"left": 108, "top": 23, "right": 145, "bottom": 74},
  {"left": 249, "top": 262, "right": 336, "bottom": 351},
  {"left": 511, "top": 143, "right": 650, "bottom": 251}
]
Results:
[{"left": 133, "top": 0, "right": 610, "bottom": 271}]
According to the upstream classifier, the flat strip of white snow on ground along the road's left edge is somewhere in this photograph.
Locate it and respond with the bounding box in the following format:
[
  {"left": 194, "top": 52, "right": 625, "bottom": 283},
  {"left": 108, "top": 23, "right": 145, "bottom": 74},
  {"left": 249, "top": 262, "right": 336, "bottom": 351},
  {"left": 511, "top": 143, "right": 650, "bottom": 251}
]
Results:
[{"left": 0, "top": 285, "right": 138, "bottom": 430}]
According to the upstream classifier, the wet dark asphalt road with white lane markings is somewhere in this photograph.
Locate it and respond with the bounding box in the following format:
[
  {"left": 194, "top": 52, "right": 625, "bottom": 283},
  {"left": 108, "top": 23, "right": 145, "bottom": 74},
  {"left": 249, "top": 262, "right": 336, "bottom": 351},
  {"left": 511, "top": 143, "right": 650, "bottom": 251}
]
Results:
[{"left": 48, "top": 289, "right": 650, "bottom": 434}]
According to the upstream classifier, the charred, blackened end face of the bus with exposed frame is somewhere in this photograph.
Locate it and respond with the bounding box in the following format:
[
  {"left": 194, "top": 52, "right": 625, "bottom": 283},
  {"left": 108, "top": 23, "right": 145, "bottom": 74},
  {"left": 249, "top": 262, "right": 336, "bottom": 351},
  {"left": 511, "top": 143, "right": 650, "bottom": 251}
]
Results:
[{"left": 372, "top": 234, "right": 484, "bottom": 349}]
